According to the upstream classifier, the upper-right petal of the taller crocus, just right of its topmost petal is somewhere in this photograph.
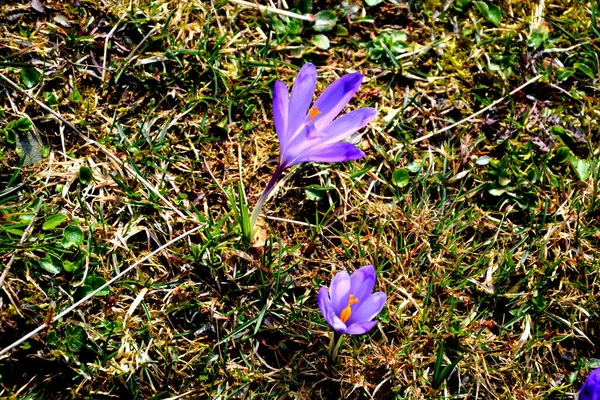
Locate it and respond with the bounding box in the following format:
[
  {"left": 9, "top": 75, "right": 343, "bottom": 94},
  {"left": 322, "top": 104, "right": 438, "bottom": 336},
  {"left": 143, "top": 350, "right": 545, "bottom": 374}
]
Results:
[{"left": 314, "top": 72, "right": 363, "bottom": 129}]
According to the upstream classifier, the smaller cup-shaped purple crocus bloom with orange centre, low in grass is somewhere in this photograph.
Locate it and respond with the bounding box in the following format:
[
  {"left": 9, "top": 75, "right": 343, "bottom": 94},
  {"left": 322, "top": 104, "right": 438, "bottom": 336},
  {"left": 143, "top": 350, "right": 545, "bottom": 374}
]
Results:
[{"left": 317, "top": 265, "right": 387, "bottom": 335}]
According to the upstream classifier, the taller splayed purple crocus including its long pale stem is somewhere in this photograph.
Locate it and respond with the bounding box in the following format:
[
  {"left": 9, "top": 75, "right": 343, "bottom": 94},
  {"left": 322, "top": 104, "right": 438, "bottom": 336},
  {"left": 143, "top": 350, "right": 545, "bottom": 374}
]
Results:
[{"left": 250, "top": 63, "right": 377, "bottom": 236}]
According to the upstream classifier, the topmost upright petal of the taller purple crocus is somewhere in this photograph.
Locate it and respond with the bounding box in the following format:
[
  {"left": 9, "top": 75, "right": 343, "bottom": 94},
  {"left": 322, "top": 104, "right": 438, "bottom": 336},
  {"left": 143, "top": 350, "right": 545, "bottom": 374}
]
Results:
[{"left": 288, "top": 63, "right": 317, "bottom": 141}]
